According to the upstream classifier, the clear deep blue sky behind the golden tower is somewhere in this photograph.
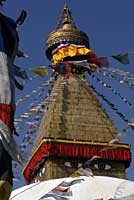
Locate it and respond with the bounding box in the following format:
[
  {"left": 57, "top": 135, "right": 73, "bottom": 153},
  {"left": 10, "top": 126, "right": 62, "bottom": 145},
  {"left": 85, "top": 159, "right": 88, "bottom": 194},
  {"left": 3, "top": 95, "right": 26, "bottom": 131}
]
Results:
[{"left": 1, "top": 0, "right": 134, "bottom": 189}]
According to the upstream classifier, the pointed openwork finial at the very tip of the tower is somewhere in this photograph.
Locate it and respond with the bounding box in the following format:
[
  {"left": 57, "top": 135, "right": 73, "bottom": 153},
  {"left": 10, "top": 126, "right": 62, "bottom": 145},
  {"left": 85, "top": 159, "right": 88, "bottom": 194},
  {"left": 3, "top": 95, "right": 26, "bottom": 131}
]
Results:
[{"left": 56, "top": 4, "right": 76, "bottom": 29}]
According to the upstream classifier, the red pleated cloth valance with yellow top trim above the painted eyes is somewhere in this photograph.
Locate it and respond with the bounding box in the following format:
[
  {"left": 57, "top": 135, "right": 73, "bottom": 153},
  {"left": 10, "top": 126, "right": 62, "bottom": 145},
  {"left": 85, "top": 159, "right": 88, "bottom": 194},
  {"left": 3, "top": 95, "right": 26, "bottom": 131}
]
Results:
[{"left": 23, "top": 139, "right": 131, "bottom": 183}]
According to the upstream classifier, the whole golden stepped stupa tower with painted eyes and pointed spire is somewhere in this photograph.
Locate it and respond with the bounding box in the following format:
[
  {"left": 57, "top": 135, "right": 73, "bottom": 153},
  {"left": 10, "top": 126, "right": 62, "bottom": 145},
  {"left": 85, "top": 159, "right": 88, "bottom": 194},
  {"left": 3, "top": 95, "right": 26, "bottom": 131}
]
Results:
[{"left": 23, "top": 5, "right": 131, "bottom": 183}]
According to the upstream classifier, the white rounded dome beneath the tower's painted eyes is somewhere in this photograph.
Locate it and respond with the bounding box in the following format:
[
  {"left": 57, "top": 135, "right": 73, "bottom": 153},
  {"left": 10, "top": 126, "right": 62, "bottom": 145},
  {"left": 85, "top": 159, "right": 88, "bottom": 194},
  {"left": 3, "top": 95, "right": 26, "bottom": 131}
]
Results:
[{"left": 10, "top": 176, "right": 134, "bottom": 200}]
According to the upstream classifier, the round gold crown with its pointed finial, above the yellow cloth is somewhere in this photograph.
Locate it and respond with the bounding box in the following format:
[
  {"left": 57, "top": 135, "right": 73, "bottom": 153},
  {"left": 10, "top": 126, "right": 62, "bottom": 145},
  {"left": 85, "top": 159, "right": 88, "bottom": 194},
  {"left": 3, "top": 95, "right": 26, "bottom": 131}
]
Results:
[{"left": 45, "top": 4, "right": 90, "bottom": 60}]
